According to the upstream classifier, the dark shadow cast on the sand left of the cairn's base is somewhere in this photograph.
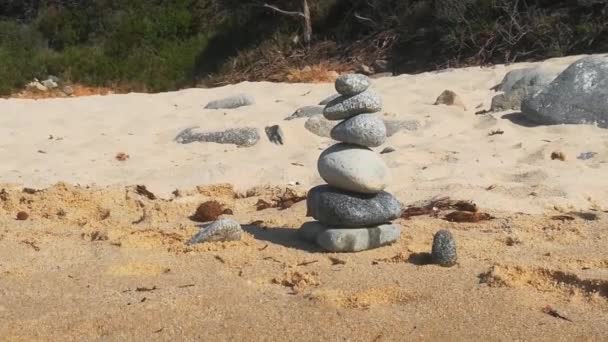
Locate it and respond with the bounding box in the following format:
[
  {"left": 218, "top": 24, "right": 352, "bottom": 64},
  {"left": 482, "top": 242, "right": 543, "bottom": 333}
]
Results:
[{"left": 243, "top": 225, "right": 323, "bottom": 253}]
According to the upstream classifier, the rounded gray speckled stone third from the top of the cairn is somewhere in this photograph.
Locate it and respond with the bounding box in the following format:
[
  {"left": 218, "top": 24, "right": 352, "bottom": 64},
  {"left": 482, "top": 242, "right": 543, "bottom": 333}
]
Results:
[{"left": 330, "top": 114, "right": 386, "bottom": 147}]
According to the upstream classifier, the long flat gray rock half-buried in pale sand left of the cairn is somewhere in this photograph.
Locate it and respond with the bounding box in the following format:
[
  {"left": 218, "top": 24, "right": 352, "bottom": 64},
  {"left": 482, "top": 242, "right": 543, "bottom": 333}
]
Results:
[{"left": 175, "top": 127, "right": 260, "bottom": 147}]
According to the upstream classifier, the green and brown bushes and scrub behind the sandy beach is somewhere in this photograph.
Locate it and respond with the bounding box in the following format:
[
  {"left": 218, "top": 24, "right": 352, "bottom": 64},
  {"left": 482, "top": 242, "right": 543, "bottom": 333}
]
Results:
[{"left": 0, "top": 0, "right": 608, "bottom": 94}]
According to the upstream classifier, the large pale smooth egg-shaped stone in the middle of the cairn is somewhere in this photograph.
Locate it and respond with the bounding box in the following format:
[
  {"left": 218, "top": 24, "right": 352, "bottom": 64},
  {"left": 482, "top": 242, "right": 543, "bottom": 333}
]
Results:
[{"left": 317, "top": 143, "right": 391, "bottom": 194}]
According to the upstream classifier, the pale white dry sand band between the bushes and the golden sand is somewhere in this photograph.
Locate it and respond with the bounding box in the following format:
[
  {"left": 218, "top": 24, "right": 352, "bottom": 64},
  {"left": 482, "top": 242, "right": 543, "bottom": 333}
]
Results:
[{"left": 0, "top": 57, "right": 608, "bottom": 213}]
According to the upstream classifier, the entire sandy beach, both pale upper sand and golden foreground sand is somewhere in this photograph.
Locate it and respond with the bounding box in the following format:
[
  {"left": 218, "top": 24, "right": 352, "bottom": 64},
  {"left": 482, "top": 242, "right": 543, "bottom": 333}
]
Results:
[{"left": 0, "top": 57, "right": 608, "bottom": 341}]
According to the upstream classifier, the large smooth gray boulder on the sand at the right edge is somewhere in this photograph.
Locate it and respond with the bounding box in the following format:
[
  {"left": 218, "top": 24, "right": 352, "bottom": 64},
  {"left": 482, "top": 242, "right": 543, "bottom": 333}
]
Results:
[{"left": 521, "top": 56, "right": 608, "bottom": 128}]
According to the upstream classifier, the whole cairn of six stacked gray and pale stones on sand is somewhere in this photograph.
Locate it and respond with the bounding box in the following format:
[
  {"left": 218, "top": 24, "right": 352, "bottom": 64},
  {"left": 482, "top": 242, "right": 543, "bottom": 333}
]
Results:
[{"left": 299, "top": 74, "right": 402, "bottom": 252}]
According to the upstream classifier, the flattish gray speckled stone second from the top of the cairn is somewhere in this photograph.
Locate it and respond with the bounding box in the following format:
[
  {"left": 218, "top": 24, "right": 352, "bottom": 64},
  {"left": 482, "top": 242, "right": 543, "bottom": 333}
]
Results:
[{"left": 323, "top": 90, "right": 382, "bottom": 120}]
